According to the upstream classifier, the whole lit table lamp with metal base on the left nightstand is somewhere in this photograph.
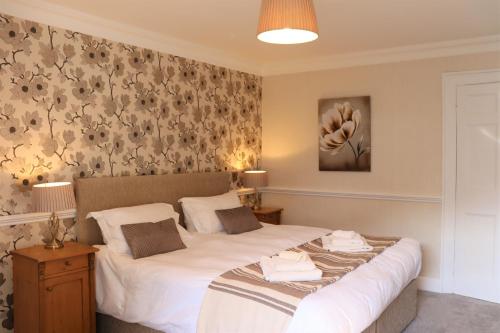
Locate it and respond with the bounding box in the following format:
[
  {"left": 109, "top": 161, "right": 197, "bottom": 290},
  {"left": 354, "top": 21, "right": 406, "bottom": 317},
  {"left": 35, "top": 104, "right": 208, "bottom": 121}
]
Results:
[{"left": 31, "top": 182, "right": 76, "bottom": 249}]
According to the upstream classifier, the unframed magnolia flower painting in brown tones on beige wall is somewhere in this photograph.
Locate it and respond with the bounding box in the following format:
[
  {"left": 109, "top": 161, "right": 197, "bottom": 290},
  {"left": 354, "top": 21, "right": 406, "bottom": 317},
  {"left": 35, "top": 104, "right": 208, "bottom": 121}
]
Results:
[{"left": 318, "top": 96, "right": 371, "bottom": 171}]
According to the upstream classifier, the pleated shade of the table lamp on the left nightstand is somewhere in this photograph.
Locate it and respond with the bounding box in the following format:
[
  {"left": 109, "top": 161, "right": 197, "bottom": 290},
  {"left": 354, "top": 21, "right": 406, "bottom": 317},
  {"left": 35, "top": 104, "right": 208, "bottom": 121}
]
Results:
[{"left": 31, "top": 182, "right": 76, "bottom": 213}]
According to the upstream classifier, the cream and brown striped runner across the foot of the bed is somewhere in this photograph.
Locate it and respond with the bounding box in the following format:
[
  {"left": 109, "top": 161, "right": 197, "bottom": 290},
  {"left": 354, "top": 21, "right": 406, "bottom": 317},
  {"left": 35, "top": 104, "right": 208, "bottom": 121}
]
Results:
[{"left": 198, "top": 236, "right": 400, "bottom": 332}]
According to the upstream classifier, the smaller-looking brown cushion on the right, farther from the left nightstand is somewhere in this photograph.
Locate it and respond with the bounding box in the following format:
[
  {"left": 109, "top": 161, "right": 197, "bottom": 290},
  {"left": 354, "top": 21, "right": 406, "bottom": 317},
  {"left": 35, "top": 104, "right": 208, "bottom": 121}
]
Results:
[{"left": 215, "top": 206, "right": 262, "bottom": 234}]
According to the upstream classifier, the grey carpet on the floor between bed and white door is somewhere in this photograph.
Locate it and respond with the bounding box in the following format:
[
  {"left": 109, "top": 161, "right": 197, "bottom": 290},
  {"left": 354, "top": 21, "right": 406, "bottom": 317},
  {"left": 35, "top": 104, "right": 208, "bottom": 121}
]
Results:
[{"left": 404, "top": 292, "right": 500, "bottom": 333}]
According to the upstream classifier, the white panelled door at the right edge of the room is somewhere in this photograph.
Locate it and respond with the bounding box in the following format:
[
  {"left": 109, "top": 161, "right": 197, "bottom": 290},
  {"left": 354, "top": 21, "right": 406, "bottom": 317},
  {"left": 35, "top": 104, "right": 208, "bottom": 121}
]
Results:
[{"left": 453, "top": 82, "right": 500, "bottom": 303}]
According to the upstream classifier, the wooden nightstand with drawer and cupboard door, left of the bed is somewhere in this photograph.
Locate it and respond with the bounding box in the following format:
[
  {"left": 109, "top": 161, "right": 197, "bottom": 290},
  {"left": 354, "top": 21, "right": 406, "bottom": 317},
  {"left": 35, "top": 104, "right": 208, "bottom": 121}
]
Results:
[{"left": 12, "top": 242, "right": 98, "bottom": 333}]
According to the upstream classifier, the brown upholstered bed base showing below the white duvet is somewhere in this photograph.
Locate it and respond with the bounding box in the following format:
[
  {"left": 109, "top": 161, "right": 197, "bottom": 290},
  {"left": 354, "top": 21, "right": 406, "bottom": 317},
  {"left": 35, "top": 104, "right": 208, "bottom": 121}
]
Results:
[{"left": 97, "top": 280, "right": 417, "bottom": 333}]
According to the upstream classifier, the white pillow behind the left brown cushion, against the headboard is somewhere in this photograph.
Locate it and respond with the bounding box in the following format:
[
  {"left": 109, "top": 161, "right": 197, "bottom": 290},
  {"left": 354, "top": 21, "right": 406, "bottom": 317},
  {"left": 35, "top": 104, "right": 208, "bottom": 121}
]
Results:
[{"left": 87, "top": 203, "right": 192, "bottom": 254}]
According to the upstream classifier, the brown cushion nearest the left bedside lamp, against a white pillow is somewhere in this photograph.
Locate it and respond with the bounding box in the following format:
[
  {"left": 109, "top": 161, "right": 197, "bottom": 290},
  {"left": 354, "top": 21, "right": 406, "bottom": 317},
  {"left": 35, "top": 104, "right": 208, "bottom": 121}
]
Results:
[{"left": 121, "top": 218, "right": 186, "bottom": 259}]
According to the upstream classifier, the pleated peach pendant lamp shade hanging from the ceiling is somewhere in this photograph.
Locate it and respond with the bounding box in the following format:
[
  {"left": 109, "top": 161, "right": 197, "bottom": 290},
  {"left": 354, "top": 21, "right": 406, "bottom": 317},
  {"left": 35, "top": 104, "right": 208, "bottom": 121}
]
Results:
[{"left": 257, "top": 0, "right": 318, "bottom": 44}]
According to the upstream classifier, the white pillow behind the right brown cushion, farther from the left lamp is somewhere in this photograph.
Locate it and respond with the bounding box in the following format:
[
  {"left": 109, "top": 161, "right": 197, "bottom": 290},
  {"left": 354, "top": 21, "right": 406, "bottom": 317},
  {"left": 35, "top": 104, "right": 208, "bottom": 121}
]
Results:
[{"left": 179, "top": 191, "right": 241, "bottom": 234}]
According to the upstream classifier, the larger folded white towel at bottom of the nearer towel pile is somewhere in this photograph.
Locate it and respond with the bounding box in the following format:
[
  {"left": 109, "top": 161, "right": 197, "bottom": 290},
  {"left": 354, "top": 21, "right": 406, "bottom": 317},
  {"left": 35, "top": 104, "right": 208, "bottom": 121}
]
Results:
[{"left": 260, "top": 257, "right": 323, "bottom": 282}]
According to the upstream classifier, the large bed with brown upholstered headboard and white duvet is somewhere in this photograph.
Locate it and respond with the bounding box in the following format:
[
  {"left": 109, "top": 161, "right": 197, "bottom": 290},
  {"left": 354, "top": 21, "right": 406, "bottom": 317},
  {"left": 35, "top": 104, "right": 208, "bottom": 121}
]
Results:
[{"left": 76, "top": 173, "right": 420, "bottom": 333}]
